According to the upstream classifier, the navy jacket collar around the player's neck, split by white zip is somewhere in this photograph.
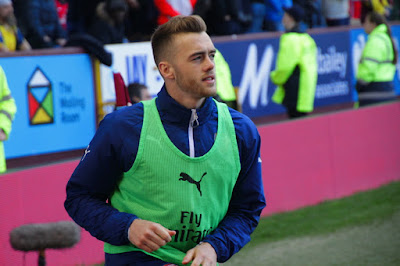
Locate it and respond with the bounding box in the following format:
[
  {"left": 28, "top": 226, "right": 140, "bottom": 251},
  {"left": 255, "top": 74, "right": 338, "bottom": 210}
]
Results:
[{"left": 156, "top": 85, "right": 216, "bottom": 125}]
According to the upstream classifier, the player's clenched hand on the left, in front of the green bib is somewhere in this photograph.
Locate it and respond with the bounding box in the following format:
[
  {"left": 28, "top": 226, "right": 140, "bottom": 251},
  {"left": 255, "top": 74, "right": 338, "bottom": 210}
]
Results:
[{"left": 128, "top": 219, "right": 176, "bottom": 252}]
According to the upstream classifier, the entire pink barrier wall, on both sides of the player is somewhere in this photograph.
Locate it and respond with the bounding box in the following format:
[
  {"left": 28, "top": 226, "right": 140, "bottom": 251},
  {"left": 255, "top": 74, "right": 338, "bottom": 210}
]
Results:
[{"left": 0, "top": 103, "right": 400, "bottom": 266}]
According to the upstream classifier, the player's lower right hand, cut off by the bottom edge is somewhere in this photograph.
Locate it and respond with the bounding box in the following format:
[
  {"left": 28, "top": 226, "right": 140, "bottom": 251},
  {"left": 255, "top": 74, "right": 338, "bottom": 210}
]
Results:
[{"left": 182, "top": 242, "right": 217, "bottom": 266}]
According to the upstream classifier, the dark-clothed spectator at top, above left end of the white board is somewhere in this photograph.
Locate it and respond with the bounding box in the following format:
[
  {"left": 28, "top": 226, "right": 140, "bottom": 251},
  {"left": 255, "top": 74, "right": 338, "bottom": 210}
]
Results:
[{"left": 88, "top": 0, "right": 128, "bottom": 44}]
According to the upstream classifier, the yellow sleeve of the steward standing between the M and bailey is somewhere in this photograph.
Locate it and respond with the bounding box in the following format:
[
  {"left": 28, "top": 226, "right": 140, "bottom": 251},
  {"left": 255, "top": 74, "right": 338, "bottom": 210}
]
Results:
[{"left": 271, "top": 33, "right": 301, "bottom": 86}]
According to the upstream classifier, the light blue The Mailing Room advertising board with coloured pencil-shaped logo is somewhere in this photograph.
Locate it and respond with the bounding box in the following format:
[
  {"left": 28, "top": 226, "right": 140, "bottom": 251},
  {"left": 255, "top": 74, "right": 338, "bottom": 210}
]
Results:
[{"left": 0, "top": 54, "right": 96, "bottom": 159}]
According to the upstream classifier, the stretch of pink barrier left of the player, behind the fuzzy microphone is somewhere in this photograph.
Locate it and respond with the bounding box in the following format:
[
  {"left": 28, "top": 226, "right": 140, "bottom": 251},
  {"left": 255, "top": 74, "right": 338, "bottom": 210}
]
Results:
[{"left": 0, "top": 160, "right": 104, "bottom": 266}]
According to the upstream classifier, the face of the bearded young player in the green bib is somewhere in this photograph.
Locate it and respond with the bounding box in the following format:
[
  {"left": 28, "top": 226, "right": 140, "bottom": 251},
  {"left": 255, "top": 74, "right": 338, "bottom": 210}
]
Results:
[{"left": 170, "top": 32, "right": 216, "bottom": 99}]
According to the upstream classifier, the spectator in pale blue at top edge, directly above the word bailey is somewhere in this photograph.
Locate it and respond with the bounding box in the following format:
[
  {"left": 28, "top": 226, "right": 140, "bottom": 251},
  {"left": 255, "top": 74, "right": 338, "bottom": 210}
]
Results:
[{"left": 322, "top": 0, "right": 350, "bottom": 27}]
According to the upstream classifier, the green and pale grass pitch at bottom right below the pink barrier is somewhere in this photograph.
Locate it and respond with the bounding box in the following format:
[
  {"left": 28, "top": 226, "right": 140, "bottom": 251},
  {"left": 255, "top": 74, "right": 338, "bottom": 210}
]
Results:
[{"left": 223, "top": 182, "right": 400, "bottom": 266}]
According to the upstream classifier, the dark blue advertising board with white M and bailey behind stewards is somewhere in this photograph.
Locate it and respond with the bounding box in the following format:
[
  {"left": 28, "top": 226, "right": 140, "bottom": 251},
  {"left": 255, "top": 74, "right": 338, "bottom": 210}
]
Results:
[{"left": 215, "top": 25, "right": 400, "bottom": 117}]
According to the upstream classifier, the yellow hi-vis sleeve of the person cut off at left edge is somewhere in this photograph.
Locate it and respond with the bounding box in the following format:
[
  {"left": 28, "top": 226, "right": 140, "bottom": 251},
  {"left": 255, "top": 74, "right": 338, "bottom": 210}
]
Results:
[{"left": 0, "top": 67, "right": 17, "bottom": 138}]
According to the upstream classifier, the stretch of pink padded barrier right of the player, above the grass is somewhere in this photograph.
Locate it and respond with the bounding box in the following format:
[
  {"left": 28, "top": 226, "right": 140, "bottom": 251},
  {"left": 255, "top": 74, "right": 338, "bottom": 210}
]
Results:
[{"left": 259, "top": 102, "right": 400, "bottom": 215}]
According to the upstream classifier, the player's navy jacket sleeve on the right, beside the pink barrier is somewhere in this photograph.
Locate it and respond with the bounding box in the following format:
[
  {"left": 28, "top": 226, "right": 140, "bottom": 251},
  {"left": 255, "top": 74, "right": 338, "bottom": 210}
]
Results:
[{"left": 203, "top": 111, "right": 265, "bottom": 262}]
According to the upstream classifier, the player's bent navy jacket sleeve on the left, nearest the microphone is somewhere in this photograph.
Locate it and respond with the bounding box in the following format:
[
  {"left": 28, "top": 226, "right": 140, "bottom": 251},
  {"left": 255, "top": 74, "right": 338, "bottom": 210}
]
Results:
[{"left": 64, "top": 112, "right": 140, "bottom": 245}]
